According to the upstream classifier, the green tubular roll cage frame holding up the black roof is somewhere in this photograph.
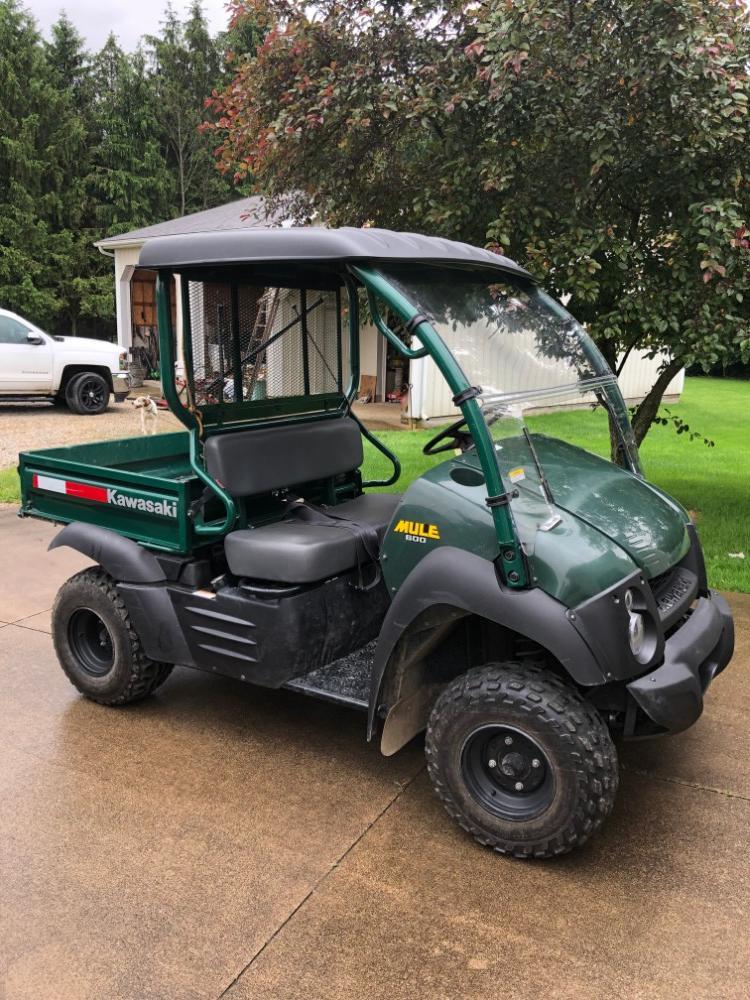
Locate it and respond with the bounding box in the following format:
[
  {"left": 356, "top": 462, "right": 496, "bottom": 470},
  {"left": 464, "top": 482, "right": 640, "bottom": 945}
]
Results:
[{"left": 156, "top": 265, "right": 528, "bottom": 588}]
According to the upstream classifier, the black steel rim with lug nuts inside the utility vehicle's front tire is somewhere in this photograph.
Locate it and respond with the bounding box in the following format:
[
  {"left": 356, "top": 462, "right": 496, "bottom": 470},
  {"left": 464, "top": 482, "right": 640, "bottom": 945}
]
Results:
[{"left": 461, "top": 726, "right": 555, "bottom": 821}]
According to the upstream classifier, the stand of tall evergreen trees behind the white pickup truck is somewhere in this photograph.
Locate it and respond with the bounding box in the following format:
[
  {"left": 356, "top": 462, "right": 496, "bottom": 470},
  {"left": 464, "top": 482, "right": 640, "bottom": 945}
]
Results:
[{"left": 0, "top": 0, "right": 234, "bottom": 335}]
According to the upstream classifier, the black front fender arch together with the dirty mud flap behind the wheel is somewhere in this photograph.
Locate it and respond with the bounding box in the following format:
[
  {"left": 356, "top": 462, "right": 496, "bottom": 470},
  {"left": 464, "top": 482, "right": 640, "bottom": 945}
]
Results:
[{"left": 367, "top": 546, "right": 605, "bottom": 755}]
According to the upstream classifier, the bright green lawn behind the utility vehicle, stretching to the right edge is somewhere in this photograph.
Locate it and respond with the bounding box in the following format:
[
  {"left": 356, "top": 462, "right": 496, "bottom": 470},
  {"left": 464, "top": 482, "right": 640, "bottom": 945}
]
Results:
[{"left": 365, "top": 378, "right": 750, "bottom": 593}]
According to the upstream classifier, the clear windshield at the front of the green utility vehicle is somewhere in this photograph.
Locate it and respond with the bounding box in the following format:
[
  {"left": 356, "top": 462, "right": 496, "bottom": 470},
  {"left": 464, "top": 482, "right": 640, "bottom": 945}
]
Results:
[{"left": 378, "top": 265, "right": 640, "bottom": 549}]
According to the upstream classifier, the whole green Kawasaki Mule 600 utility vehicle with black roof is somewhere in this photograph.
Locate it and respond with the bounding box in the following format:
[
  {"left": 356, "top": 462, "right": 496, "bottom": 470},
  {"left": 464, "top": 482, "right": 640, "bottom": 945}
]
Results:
[{"left": 20, "top": 228, "right": 734, "bottom": 857}]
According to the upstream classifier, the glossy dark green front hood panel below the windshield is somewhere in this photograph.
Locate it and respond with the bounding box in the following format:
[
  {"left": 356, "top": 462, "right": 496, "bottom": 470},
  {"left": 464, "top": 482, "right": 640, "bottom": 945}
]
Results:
[{"left": 528, "top": 434, "right": 689, "bottom": 577}]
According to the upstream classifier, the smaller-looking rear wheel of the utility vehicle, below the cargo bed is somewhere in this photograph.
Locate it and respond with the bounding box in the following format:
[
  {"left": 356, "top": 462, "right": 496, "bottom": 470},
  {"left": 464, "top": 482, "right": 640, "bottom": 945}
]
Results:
[{"left": 52, "top": 566, "right": 172, "bottom": 705}]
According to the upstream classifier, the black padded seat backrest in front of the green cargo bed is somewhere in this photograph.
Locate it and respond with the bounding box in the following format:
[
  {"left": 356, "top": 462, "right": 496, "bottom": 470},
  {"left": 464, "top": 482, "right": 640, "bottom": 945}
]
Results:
[{"left": 204, "top": 417, "right": 364, "bottom": 497}]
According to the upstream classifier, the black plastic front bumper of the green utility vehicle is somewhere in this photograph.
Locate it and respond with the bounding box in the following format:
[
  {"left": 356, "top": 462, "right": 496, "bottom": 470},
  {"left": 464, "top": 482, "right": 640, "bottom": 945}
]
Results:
[{"left": 625, "top": 590, "right": 734, "bottom": 739}]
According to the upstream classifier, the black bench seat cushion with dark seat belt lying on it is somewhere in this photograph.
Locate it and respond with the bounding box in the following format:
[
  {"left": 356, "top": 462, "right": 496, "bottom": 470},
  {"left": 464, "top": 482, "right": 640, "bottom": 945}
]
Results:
[{"left": 224, "top": 493, "right": 401, "bottom": 583}]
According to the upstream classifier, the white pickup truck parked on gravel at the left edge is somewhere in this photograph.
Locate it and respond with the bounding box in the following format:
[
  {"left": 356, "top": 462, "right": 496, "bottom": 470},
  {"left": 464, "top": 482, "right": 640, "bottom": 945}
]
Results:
[{"left": 0, "top": 309, "right": 130, "bottom": 415}]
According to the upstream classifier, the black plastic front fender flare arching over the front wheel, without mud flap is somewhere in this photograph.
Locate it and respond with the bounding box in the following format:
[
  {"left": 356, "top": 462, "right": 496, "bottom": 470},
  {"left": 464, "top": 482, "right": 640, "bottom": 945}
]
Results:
[{"left": 367, "top": 545, "right": 605, "bottom": 739}]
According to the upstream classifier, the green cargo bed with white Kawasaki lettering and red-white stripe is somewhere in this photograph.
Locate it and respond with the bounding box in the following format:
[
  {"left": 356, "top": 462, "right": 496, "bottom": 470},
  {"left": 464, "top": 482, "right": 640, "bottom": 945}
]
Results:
[{"left": 19, "top": 432, "right": 203, "bottom": 554}]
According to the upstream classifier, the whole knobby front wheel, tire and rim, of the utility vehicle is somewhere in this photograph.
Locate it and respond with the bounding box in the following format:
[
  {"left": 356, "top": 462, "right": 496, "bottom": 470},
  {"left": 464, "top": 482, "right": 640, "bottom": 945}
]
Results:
[{"left": 425, "top": 662, "right": 618, "bottom": 858}]
